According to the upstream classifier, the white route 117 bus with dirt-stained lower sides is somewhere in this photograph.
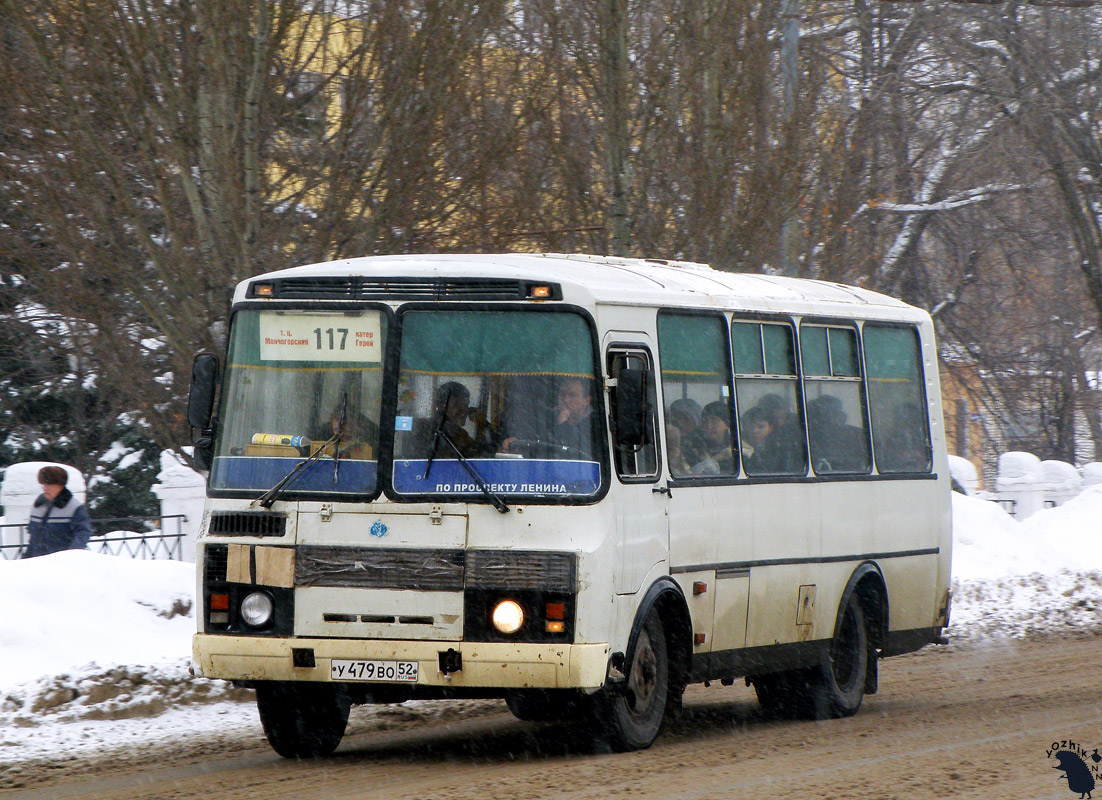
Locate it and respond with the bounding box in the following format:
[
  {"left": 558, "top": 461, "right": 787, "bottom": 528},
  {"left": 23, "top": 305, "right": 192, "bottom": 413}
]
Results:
[{"left": 188, "top": 255, "right": 951, "bottom": 757}]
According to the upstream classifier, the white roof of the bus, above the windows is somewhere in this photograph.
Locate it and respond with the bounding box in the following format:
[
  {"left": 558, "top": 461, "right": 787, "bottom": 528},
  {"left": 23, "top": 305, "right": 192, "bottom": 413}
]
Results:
[{"left": 235, "top": 253, "right": 926, "bottom": 321}]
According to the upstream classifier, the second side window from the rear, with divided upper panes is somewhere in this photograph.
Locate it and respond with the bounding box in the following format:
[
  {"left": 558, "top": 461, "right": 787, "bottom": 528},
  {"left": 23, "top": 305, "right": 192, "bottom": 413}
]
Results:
[{"left": 800, "top": 325, "right": 872, "bottom": 475}]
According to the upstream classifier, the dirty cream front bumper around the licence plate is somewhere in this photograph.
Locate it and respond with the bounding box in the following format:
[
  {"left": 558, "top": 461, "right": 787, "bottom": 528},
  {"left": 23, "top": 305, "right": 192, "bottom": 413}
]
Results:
[{"left": 192, "top": 634, "right": 609, "bottom": 690}]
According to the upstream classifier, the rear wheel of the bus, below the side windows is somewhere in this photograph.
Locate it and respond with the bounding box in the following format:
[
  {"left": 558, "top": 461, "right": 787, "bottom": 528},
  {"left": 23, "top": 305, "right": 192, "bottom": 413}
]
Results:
[{"left": 814, "top": 594, "right": 869, "bottom": 720}]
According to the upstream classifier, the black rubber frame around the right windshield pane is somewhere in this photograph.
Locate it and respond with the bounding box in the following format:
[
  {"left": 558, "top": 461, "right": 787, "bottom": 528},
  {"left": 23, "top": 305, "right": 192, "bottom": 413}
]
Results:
[{"left": 378, "top": 301, "right": 613, "bottom": 506}]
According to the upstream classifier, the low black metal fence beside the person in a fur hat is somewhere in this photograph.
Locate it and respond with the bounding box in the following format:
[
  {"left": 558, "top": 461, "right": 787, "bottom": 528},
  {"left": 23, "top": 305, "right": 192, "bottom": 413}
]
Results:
[{"left": 0, "top": 513, "right": 187, "bottom": 561}]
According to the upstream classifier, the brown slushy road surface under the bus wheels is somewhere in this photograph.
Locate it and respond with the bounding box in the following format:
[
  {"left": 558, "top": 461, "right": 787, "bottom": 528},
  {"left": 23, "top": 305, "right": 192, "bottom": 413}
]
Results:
[{"left": 3, "top": 635, "right": 1102, "bottom": 800}]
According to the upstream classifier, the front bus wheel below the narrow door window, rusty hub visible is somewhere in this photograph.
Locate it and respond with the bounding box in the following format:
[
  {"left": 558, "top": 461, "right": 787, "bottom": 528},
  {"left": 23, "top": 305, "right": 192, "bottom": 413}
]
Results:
[{"left": 597, "top": 612, "right": 670, "bottom": 753}]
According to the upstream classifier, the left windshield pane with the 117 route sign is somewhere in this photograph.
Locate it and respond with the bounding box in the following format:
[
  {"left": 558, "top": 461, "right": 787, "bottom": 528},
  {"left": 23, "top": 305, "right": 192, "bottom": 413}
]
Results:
[{"left": 210, "top": 309, "right": 387, "bottom": 496}]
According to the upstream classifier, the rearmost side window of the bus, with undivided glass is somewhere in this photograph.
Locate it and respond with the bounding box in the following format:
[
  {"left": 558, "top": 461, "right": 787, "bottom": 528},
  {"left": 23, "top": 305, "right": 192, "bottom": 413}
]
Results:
[{"left": 863, "top": 324, "right": 931, "bottom": 473}]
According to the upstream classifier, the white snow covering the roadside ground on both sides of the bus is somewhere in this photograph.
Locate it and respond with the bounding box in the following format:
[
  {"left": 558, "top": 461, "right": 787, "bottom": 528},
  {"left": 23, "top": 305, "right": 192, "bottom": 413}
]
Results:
[{"left": 0, "top": 486, "right": 1102, "bottom": 769}]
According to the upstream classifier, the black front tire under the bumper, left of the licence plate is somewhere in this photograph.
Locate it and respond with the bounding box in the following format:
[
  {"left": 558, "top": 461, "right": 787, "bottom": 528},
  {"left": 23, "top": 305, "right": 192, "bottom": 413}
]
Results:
[{"left": 257, "top": 681, "right": 352, "bottom": 758}]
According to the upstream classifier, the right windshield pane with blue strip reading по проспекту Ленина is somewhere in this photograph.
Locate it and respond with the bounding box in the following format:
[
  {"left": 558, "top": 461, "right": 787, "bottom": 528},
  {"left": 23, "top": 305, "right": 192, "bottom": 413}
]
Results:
[{"left": 393, "top": 310, "right": 603, "bottom": 497}]
